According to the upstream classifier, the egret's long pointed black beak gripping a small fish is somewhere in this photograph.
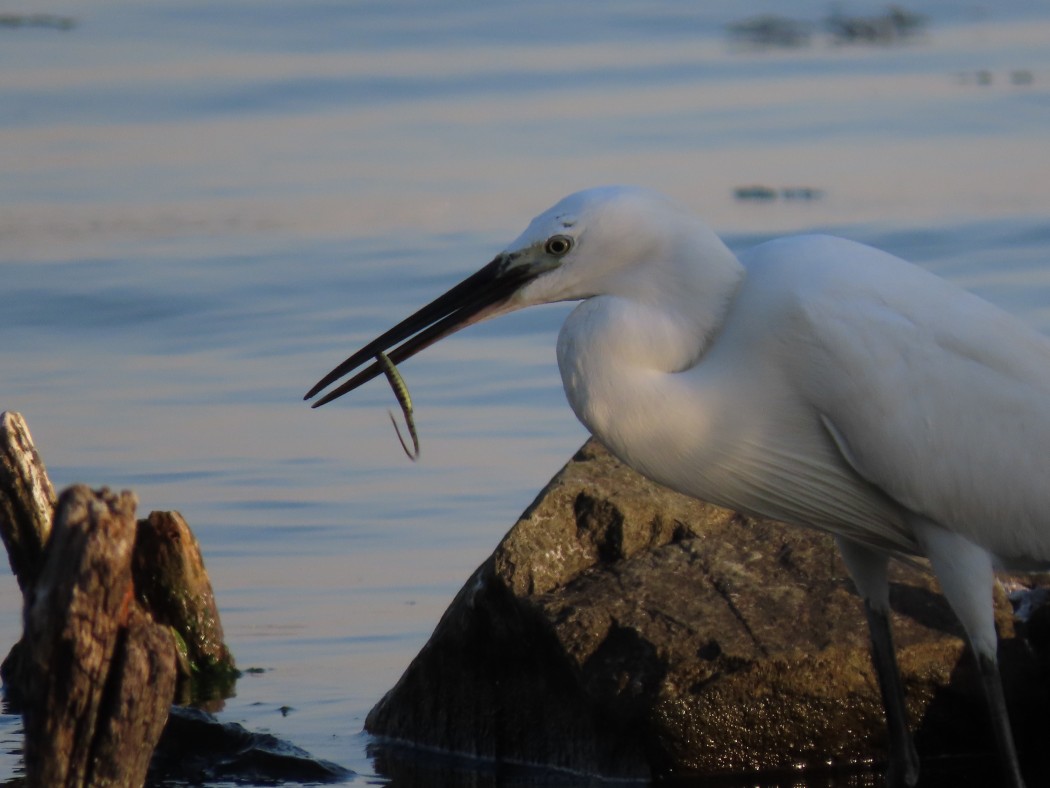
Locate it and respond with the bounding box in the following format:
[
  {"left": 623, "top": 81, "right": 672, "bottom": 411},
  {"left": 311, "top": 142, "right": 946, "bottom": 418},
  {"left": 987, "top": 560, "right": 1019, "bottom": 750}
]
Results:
[{"left": 303, "top": 254, "right": 539, "bottom": 408}]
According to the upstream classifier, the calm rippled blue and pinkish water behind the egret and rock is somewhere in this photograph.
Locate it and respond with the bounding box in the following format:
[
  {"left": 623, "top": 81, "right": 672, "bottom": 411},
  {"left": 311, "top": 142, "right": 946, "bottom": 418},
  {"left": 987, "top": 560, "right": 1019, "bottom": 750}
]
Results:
[{"left": 0, "top": 0, "right": 1050, "bottom": 784}]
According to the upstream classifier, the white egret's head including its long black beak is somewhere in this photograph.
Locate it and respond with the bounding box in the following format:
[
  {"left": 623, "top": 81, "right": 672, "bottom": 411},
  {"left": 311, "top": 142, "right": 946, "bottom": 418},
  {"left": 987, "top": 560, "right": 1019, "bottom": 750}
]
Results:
[{"left": 306, "top": 186, "right": 702, "bottom": 408}]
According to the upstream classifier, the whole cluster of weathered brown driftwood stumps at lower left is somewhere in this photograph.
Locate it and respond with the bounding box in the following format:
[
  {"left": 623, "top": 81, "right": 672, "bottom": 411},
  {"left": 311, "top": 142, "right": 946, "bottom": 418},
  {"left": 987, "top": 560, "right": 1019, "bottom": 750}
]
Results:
[{"left": 0, "top": 413, "right": 237, "bottom": 788}]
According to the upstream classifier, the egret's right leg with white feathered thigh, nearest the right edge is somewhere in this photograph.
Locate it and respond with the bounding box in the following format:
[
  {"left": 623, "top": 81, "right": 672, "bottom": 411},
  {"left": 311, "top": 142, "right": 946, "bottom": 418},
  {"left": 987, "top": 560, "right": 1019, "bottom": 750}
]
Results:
[{"left": 914, "top": 520, "right": 1025, "bottom": 788}]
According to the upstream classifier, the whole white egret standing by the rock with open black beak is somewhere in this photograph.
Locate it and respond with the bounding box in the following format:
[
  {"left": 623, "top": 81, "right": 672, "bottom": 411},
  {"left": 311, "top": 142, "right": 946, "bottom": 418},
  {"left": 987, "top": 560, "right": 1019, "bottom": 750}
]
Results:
[{"left": 307, "top": 187, "right": 1050, "bottom": 788}]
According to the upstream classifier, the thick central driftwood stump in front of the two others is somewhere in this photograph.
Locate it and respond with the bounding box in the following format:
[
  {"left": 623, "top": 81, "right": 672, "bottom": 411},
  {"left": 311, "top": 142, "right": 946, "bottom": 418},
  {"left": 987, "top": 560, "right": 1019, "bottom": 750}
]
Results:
[{"left": 20, "top": 486, "right": 175, "bottom": 787}]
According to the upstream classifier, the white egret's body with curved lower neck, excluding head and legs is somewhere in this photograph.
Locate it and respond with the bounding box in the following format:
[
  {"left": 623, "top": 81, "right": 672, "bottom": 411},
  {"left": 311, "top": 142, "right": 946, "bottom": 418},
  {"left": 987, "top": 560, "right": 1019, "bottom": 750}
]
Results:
[{"left": 558, "top": 231, "right": 1050, "bottom": 568}]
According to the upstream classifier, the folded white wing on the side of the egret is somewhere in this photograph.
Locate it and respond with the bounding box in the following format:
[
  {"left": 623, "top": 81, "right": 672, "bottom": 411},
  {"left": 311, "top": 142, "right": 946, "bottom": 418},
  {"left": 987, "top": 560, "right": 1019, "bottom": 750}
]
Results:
[{"left": 790, "top": 237, "right": 1050, "bottom": 560}]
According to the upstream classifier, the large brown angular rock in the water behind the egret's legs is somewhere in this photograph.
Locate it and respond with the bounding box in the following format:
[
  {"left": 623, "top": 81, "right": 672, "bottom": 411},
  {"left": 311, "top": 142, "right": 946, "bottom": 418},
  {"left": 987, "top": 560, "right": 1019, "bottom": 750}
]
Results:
[{"left": 365, "top": 441, "right": 1048, "bottom": 779}]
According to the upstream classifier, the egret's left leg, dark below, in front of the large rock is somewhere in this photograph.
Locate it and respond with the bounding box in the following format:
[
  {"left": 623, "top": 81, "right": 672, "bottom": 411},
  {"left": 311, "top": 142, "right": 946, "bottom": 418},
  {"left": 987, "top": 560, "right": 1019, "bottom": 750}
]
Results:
[{"left": 836, "top": 538, "right": 919, "bottom": 788}]
